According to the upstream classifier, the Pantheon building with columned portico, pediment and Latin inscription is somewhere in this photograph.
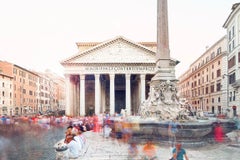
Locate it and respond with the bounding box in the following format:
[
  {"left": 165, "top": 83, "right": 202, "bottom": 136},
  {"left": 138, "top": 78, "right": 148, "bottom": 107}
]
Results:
[{"left": 61, "top": 36, "right": 157, "bottom": 116}]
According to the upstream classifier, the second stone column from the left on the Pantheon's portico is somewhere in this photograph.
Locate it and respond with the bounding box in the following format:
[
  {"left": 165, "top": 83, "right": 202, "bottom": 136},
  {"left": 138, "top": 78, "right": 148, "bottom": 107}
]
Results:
[{"left": 80, "top": 74, "right": 86, "bottom": 116}]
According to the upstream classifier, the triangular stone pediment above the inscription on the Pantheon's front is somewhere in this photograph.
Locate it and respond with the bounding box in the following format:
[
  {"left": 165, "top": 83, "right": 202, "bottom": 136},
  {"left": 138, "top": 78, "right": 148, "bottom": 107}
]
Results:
[{"left": 61, "top": 37, "right": 156, "bottom": 65}]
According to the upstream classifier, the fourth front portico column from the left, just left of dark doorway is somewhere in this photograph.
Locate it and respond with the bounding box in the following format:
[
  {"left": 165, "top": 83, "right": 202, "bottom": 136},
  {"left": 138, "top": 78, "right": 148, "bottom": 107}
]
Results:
[{"left": 109, "top": 74, "right": 115, "bottom": 115}]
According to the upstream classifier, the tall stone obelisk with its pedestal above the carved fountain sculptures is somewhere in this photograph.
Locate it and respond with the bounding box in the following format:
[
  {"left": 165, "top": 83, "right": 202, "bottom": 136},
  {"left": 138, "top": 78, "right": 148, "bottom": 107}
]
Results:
[{"left": 152, "top": 0, "right": 176, "bottom": 81}]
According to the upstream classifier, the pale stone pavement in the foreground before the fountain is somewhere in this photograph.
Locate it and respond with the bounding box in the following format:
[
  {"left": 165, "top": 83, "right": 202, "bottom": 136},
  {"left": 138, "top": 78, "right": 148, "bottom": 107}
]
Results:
[{"left": 73, "top": 132, "right": 240, "bottom": 160}]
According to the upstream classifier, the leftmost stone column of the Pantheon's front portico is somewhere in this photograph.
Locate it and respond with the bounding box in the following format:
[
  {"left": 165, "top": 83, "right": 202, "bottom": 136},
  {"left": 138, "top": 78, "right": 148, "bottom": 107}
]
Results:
[{"left": 65, "top": 74, "right": 71, "bottom": 115}]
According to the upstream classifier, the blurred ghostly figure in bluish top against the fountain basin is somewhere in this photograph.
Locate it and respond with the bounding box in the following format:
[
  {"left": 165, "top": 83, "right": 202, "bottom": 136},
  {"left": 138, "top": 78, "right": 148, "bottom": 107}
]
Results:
[{"left": 168, "top": 119, "right": 182, "bottom": 147}]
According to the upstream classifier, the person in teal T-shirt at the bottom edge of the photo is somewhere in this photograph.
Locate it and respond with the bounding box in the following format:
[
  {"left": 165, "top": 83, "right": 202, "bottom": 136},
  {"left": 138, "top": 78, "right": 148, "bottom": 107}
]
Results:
[{"left": 170, "top": 142, "right": 189, "bottom": 160}]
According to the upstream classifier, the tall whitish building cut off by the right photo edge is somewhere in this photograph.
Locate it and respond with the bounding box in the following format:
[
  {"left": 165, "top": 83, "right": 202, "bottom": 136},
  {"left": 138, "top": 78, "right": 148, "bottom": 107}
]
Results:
[{"left": 223, "top": 3, "right": 240, "bottom": 116}]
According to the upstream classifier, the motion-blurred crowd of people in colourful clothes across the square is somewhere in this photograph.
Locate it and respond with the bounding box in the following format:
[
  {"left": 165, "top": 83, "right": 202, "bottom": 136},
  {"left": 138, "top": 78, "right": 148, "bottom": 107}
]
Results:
[{"left": 0, "top": 114, "right": 240, "bottom": 160}]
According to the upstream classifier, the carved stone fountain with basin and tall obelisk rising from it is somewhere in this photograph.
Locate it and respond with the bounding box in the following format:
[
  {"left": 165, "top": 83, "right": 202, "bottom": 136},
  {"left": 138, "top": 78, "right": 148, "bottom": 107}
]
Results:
[{"left": 124, "top": 0, "right": 235, "bottom": 146}]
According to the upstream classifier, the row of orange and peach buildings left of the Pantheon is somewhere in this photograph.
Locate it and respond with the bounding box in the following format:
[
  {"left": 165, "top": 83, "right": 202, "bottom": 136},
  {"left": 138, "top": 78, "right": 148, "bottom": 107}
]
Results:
[{"left": 0, "top": 61, "right": 65, "bottom": 115}]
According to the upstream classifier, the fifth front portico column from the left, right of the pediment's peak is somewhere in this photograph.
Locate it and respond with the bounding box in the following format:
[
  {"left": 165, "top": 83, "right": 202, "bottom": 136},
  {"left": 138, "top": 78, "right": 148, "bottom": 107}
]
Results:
[{"left": 125, "top": 74, "right": 131, "bottom": 115}]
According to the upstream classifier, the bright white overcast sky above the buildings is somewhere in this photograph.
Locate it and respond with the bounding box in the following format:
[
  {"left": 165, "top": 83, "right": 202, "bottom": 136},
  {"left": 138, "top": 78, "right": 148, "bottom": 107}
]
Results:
[{"left": 0, "top": 0, "right": 239, "bottom": 77}]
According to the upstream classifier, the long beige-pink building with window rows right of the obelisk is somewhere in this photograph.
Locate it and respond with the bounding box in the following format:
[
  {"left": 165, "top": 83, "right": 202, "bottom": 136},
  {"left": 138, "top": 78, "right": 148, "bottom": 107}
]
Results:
[{"left": 178, "top": 36, "right": 229, "bottom": 115}]
